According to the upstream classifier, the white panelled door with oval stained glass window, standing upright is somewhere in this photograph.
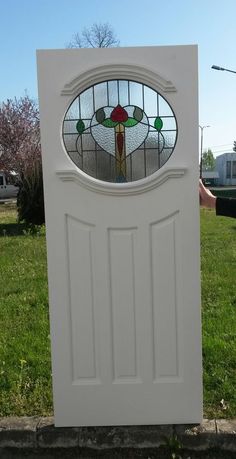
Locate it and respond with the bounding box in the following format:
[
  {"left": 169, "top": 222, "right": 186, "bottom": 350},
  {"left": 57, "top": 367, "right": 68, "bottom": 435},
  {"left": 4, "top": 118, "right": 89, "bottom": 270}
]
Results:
[{"left": 38, "top": 46, "right": 202, "bottom": 426}]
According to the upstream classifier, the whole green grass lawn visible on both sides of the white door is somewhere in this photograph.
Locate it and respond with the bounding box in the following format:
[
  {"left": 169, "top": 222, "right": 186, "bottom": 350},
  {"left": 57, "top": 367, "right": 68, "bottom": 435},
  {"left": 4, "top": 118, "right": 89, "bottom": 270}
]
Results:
[{"left": 0, "top": 204, "right": 236, "bottom": 417}]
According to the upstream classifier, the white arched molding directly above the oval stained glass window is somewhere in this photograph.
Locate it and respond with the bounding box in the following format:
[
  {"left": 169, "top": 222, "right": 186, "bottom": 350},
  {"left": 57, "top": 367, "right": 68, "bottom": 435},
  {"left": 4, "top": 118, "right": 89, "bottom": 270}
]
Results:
[{"left": 61, "top": 64, "right": 177, "bottom": 96}]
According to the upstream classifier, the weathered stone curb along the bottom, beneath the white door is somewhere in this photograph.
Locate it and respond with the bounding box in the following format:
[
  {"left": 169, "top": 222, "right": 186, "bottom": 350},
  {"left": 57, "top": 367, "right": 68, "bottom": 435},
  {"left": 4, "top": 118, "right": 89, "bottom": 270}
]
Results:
[{"left": 0, "top": 416, "right": 236, "bottom": 459}]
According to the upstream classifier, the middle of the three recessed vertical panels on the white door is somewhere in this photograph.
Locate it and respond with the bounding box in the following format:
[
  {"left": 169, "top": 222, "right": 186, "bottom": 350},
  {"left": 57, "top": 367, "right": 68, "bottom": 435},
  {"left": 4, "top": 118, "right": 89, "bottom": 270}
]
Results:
[{"left": 108, "top": 228, "right": 138, "bottom": 383}]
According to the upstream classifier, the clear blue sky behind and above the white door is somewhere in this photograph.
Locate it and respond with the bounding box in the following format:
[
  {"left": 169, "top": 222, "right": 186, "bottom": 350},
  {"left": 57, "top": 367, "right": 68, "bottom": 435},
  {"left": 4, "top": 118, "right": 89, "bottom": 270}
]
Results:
[{"left": 0, "top": 0, "right": 236, "bottom": 155}]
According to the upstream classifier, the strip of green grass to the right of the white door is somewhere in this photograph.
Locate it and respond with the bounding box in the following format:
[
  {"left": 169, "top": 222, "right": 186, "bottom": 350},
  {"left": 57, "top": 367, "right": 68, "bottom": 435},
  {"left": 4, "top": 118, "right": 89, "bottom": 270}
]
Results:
[{"left": 201, "top": 209, "right": 236, "bottom": 417}]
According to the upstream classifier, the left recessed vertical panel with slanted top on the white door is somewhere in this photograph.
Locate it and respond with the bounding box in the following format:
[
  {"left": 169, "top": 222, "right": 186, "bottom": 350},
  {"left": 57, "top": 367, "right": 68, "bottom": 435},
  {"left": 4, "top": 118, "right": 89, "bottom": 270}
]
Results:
[{"left": 66, "top": 215, "right": 99, "bottom": 384}]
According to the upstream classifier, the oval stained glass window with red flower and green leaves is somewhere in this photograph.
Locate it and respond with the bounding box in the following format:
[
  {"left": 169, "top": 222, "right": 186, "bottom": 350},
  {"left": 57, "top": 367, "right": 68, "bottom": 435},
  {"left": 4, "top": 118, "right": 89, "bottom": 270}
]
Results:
[{"left": 63, "top": 80, "right": 177, "bottom": 183}]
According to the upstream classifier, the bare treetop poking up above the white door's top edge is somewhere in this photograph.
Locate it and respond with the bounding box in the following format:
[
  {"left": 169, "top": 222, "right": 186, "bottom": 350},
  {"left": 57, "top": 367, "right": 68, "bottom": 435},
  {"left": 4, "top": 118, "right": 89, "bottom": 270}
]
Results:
[{"left": 68, "top": 22, "right": 120, "bottom": 48}]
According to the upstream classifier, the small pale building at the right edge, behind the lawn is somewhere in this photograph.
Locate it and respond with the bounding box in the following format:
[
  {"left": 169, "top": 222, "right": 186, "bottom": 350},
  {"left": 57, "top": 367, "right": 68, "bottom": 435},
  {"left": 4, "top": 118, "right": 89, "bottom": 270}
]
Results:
[{"left": 216, "top": 152, "right": 236, "bottom": 186}]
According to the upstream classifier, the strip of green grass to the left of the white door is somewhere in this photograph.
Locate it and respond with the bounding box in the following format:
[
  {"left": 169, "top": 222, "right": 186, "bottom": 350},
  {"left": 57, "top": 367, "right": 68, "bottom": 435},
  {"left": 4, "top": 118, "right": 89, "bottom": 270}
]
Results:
[{"left": 0, "top": 205, "right": 52, "bottom": 416}]
